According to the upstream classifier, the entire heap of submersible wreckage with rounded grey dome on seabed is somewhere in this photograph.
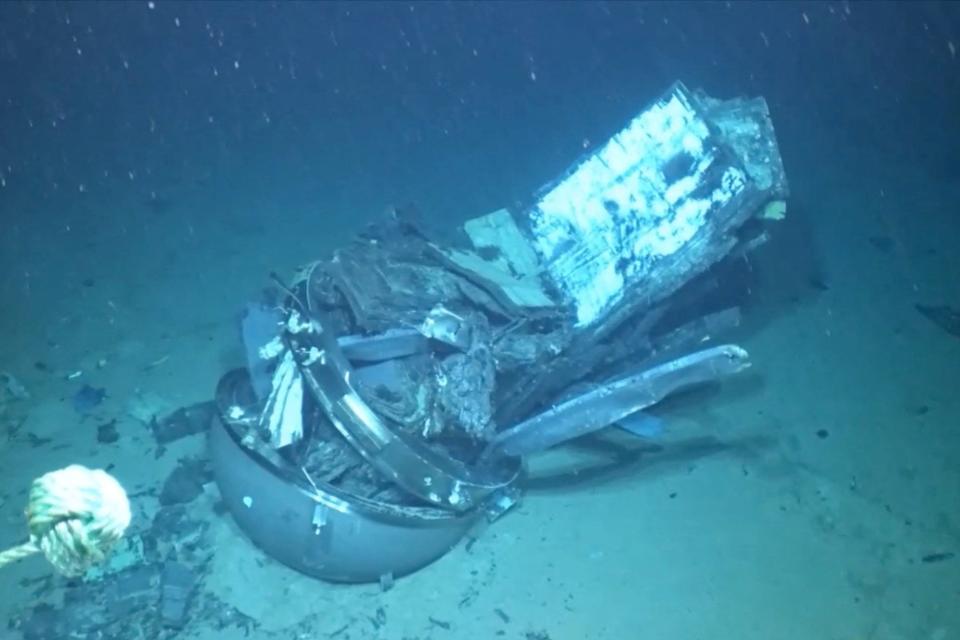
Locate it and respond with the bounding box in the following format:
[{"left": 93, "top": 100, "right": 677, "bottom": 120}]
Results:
[{"left": 209, "top": 83, "right": 787, "bottom": 583}]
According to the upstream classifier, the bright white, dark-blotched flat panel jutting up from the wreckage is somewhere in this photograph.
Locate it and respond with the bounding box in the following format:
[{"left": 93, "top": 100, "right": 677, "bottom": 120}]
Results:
[{"left": 529, "top": 84, "right": 750, "bottom": 327}]
